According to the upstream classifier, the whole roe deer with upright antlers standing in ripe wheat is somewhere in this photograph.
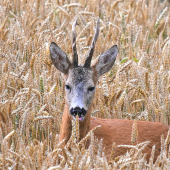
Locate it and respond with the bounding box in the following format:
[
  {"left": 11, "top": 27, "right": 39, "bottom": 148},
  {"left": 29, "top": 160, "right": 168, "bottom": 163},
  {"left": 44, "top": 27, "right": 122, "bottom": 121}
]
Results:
[{"left": 50, "top": 19, "right": 169, "bottom": 160}]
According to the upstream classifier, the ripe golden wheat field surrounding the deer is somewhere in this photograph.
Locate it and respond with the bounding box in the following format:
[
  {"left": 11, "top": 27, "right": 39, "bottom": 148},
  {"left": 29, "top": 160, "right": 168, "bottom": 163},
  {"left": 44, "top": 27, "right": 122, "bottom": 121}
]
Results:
[{"left": 0, "top": 0, "right": 170, "bottom": 170}]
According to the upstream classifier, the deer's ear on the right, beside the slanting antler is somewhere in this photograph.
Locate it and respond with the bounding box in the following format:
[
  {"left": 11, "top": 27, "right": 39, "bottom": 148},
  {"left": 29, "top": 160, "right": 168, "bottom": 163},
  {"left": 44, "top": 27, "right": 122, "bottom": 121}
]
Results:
[{"left": 92, "top": 45, "right": 118, "bottom": 76}]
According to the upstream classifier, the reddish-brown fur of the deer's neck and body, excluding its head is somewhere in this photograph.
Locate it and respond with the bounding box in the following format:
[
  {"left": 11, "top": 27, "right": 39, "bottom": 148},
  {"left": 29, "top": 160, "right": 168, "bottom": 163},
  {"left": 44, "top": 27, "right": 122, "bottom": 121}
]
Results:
[{"left": 60, "top": 101, "right": 169, "bottom": 160}]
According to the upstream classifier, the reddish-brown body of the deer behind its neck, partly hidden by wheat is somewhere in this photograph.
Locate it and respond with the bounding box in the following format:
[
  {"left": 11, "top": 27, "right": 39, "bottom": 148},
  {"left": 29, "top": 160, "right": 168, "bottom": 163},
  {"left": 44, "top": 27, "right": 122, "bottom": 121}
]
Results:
[{"left": 91, "top": 118, "right": 169, "bottom": 161}]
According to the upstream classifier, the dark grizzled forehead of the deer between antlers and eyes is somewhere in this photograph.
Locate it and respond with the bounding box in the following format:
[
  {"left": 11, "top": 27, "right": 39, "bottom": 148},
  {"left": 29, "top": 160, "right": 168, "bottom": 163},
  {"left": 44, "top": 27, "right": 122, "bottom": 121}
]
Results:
[{"left": 67, "top": 66, "right": 94, "bottom": 86}]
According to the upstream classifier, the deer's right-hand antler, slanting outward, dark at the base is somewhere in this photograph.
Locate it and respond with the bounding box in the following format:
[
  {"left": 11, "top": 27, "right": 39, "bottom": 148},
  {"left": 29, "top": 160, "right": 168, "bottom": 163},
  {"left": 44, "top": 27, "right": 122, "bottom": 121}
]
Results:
[{"left": 84, "top": 17, "right": 100, "bottom": 68}]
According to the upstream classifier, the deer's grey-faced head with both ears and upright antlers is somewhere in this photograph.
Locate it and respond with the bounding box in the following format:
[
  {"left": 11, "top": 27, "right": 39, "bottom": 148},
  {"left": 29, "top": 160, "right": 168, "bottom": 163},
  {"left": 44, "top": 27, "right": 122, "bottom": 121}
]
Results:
[{"left": 50, "top": 18, "right": 118, "bottom": 121}]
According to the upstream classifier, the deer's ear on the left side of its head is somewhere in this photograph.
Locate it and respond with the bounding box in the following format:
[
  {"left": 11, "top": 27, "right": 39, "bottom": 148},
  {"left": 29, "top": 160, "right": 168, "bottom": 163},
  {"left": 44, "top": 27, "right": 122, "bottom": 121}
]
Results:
[{"left": 50, "top": 42, "right": 71, "bottom": 74}]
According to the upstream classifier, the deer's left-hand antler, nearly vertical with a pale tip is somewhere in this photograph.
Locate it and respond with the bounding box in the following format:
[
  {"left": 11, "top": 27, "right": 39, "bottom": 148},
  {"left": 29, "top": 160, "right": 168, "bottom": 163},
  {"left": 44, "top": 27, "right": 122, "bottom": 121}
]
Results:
[{"left": 72, "top": 18, "right": 78, "bottom": 67}]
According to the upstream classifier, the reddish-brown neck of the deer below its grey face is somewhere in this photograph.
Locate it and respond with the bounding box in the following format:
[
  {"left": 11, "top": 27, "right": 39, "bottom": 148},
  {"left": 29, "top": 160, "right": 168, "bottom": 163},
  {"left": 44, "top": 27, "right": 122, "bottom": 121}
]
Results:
[{"left": 60, "top": 101, "right": 91, "bottom": 144}]
